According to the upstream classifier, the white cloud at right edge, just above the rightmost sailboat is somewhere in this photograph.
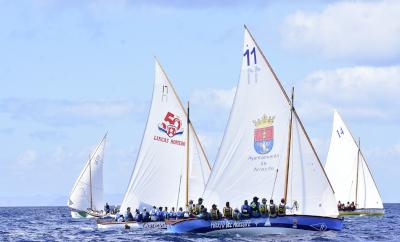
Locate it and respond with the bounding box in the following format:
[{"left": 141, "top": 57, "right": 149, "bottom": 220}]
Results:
[{"left": 297, "top": 66, "right": 400, "bottom": 121}]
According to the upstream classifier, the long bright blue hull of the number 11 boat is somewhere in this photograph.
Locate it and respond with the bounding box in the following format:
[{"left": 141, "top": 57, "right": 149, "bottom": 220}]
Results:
[{"left": 167, "top": 215, "right": 343, "bottom": 233}]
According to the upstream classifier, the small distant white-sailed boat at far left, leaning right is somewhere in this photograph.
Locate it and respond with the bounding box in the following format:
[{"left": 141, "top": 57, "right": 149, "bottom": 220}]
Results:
[{"left": 68, "top": 134, "right": 107, "bottom": 218}]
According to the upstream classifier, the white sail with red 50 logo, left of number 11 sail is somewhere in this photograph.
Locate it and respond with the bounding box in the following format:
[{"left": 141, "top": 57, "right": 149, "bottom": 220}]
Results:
[{"left": 121, "top": 61, "right": 210, "bottom": 211}]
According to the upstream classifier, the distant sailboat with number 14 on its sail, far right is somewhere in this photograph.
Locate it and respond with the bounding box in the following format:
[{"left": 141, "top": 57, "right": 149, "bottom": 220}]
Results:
[{"left": 325, "top": 110, "right": 384, "bottom": 215}]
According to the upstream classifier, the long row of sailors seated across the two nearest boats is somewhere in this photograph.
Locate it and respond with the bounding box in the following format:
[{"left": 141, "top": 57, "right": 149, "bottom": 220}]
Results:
[{"left": 115, "top": 197, "right": 298, "bottom": 222}]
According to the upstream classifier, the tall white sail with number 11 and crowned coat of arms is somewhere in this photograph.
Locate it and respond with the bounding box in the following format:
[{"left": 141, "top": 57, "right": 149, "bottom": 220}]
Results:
[{"left": 204, "top": 28, "right": 338, "bottom": 217}]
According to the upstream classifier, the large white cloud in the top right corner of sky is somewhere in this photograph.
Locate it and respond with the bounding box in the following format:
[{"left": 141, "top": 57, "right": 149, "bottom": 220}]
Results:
[{"left": 281, "top": 0, "right": 400, "bottom": 60}]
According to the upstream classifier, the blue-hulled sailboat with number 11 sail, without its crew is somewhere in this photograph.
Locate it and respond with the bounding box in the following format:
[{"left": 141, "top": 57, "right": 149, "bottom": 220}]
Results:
[{"left": 168, "top": 26, "right": 343, "bottom": 233}]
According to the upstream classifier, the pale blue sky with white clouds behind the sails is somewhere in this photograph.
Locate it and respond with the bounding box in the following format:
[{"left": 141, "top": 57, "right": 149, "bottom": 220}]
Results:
[{"left": 0, "top": 0, "right": 400, "bottom": 206}]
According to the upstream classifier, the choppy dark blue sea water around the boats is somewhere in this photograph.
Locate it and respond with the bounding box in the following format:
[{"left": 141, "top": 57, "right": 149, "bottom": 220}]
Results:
[{"left": 0, "top": 204, "right": 400, "bottom": 241}]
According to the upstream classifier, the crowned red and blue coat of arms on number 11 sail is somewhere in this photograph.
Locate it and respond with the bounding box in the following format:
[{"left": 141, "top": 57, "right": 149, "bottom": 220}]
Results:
[{"left": 253, "top": 114, "right": 275, "bottom": 154}]
